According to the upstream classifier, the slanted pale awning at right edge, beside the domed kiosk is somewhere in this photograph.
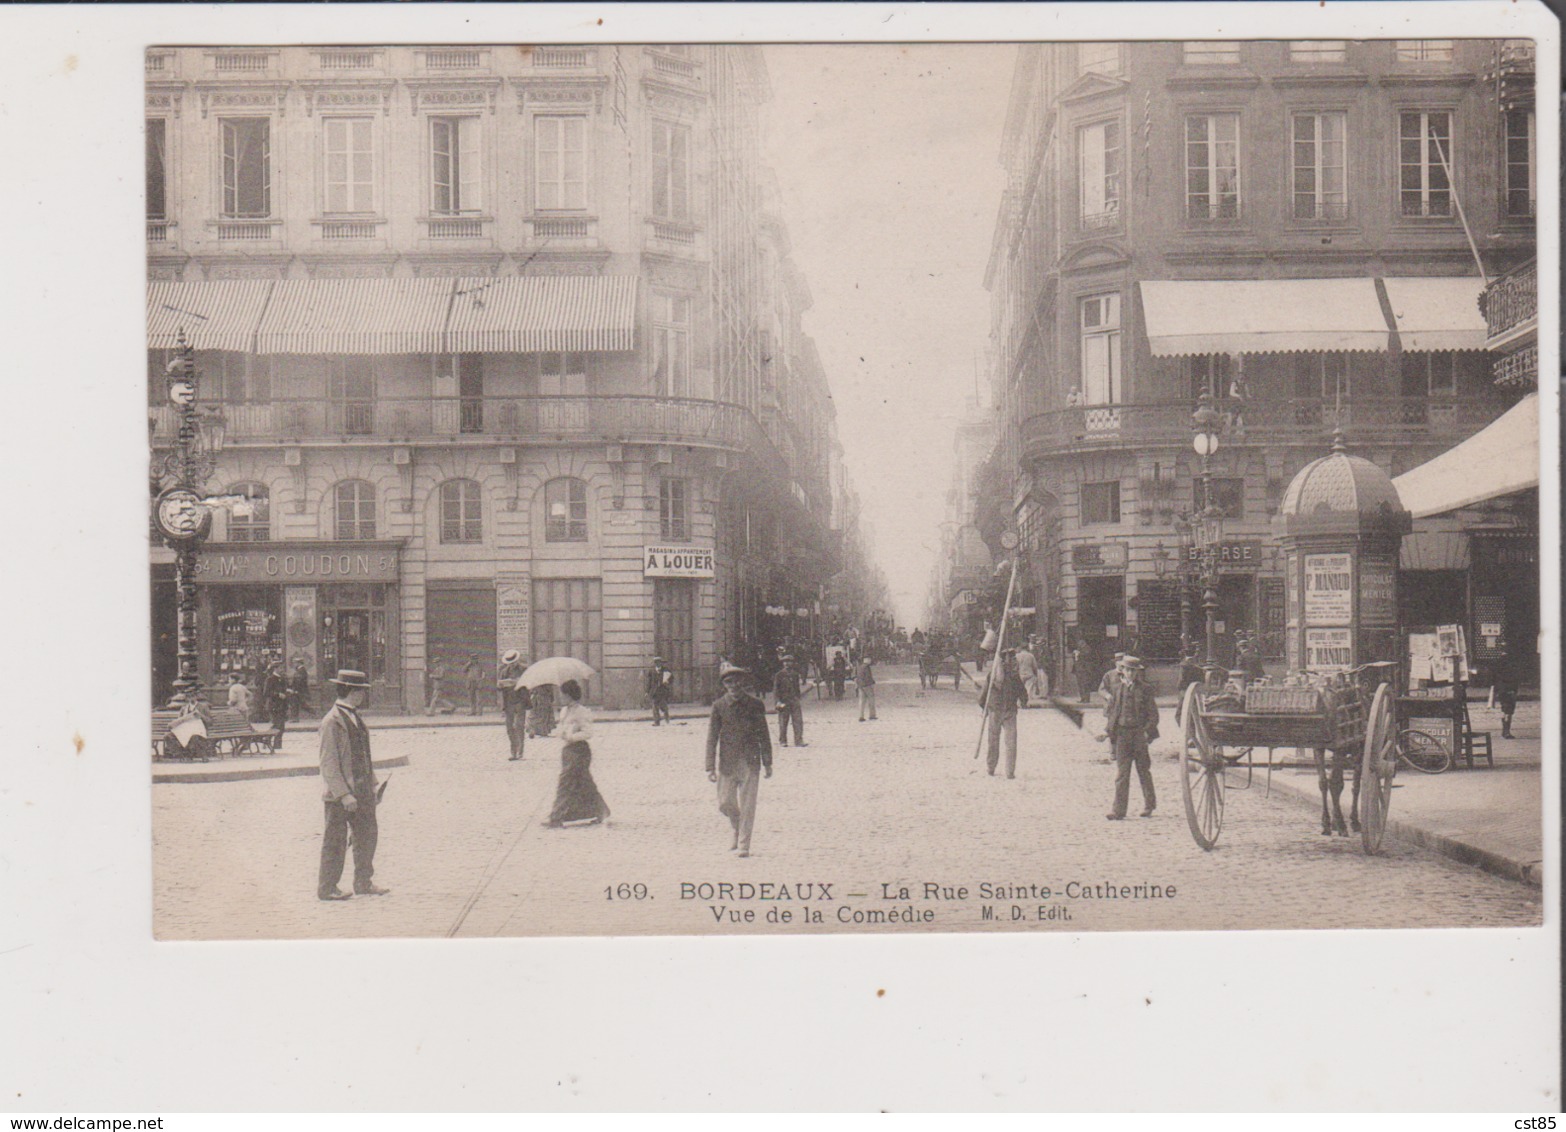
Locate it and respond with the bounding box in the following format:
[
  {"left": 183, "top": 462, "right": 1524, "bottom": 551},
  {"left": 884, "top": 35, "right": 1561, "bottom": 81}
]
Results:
[{"left": 1392, "top": 393, "right": 1539, "bottom": 518}]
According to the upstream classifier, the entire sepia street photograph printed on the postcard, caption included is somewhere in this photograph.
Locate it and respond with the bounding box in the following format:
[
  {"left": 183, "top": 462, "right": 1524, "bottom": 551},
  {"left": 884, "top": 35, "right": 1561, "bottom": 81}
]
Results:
[{"left": 137, "top": 28, "right": 1558, "bottom": 961}]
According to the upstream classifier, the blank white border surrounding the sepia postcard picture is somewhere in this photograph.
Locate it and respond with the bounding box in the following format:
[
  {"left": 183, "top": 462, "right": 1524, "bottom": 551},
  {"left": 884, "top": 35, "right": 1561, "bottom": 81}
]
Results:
[{"left": 0, "top": 0, "right": 1560, "bottom": 1113}]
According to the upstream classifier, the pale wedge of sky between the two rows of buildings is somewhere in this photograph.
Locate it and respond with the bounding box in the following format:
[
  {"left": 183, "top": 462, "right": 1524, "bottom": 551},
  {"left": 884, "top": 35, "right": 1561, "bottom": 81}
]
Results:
[{"left": 763, "top": 44, "right": 1016, "bottom": 628}]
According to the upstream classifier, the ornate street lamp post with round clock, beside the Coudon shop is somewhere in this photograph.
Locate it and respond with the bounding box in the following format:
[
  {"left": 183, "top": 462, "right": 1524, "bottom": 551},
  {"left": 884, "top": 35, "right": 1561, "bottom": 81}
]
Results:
[{"left": 152, "top": 329, "right": 224, "bottom": 709}]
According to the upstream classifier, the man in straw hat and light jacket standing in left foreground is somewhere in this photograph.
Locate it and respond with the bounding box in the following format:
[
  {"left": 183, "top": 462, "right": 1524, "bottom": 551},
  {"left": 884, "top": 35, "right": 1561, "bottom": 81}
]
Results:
[{"left": 316, "top": 669, "right": 390, "bottom": 900}]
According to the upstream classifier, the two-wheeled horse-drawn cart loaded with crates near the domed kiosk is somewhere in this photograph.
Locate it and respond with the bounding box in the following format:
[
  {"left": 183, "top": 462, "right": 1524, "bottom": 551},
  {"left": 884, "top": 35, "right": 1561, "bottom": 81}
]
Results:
[{"left": 1179, "top": 664, "right": 1397, "bottom": 853}]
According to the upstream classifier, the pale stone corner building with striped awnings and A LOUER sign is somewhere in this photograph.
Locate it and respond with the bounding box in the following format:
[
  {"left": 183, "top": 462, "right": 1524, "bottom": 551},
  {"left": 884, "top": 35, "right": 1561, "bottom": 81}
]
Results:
[{"left": 146, "top": 45, "right": 841, "bottom": 709}]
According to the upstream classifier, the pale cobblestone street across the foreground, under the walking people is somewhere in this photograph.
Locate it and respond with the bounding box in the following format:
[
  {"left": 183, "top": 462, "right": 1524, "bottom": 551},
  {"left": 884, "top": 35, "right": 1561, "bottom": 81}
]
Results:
[{"left": 153, "top": 670, "right": 1541, "bottom": 939}]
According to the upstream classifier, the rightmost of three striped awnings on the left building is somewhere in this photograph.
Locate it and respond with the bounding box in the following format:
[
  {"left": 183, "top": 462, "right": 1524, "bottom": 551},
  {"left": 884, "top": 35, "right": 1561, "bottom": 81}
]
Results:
[{"left": 446, "top": 276, "right": 636, "bottom": 354}]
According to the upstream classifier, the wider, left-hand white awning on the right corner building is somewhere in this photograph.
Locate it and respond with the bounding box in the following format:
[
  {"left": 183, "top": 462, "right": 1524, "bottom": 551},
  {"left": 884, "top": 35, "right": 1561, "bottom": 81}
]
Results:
[{"left": 1140, "top": 279, "right": 1387, "bottom": 357}]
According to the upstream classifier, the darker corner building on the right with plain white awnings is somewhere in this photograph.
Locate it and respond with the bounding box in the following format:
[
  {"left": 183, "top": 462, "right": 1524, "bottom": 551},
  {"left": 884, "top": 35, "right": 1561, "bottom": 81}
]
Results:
[{"left": 985, "top": 39, "right": 1536, "bottom": 692}]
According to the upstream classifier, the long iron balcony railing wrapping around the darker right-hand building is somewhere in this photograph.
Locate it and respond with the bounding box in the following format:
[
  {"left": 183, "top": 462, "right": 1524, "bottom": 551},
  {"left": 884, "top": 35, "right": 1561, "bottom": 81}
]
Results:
[{"left": 1023, "top": 395, "right": 1510, "bottom": 456}]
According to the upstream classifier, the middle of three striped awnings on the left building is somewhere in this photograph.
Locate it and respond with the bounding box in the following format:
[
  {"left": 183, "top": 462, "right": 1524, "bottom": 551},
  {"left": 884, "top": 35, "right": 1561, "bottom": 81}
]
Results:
[{"left": 255, "top": 279, "right": 453, "bottom": 354}]
